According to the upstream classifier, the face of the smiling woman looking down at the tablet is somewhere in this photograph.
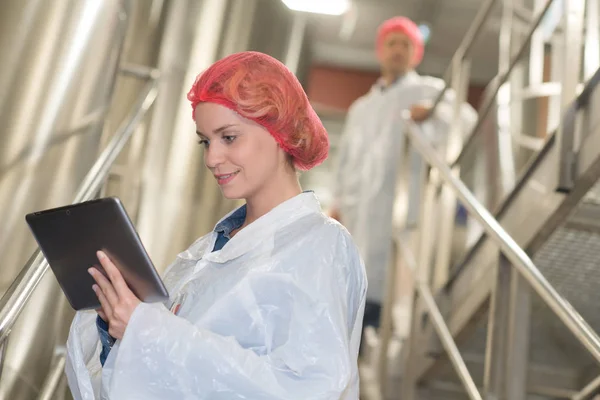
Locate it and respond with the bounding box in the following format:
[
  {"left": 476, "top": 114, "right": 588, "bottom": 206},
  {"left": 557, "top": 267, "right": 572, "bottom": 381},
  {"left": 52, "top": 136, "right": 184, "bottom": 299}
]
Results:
[{"left": 194, "top": 103, "right": 286, "bottom": 199}]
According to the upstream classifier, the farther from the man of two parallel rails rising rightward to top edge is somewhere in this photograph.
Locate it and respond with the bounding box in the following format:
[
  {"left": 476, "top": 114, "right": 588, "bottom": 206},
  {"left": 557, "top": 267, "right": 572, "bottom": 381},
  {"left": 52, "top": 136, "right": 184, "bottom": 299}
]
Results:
[{"left": 452, "top": 0, "right": 554, "bottom": 166}]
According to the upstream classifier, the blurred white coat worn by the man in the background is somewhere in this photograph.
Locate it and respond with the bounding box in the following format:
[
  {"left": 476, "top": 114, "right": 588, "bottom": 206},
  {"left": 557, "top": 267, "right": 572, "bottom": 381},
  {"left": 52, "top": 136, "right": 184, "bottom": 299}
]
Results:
[{"left": 333, "top": 71, "right": 477, "bottom": 304}]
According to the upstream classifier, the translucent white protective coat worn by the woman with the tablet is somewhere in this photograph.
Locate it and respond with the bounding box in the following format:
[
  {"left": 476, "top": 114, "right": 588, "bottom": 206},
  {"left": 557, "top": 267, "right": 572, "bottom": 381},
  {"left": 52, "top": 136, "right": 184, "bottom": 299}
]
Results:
[{"left": 66, "top": 192, "right": 366, "bottom": 400}]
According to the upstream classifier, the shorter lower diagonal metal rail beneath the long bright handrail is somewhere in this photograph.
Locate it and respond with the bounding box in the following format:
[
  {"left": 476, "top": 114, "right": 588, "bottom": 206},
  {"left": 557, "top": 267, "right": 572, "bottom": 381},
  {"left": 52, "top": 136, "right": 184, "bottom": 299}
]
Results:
[{"left": 397, "top": 234, "right": 482, "bottom": 400}]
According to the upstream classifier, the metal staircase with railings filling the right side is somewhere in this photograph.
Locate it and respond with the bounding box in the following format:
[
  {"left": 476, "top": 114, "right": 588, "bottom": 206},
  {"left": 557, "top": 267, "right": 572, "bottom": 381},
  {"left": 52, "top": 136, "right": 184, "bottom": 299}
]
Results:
[{"left": 372, "top": 0, "right": 600, "bottom": 400}]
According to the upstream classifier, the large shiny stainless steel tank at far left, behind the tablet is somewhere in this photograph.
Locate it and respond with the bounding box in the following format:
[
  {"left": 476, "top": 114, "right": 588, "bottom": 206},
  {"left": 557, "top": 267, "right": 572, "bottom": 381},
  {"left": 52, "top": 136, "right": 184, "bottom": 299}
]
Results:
[{"left": 0, "top": 0, "right": 164, "bottom": 400}]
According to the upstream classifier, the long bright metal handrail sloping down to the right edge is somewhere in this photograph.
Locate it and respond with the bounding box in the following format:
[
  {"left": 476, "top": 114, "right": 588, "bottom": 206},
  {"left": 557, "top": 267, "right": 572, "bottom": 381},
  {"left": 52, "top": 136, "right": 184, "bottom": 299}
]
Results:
[{"left": 403, "top": 115, "right": 600, "bottom": 364}]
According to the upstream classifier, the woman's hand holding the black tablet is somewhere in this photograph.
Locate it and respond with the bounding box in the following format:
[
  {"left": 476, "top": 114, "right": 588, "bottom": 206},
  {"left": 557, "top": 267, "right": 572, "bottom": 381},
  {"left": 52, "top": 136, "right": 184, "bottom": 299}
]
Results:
[{"left": 88, "top": 251, "right": 141, "bottom": 339}]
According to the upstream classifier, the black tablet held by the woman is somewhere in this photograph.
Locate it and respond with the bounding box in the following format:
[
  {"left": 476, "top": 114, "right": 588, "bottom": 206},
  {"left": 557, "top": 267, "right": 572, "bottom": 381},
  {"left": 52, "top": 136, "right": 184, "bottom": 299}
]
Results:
[{"left": 25, "top": 197, "right": 169, "bottom": 311}]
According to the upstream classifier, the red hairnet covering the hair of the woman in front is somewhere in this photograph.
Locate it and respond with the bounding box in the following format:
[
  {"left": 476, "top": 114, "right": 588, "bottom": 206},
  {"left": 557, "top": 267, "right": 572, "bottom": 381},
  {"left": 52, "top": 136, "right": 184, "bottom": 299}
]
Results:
[{"left": 187, "top": 51, "right": 329, "bottom": 171}]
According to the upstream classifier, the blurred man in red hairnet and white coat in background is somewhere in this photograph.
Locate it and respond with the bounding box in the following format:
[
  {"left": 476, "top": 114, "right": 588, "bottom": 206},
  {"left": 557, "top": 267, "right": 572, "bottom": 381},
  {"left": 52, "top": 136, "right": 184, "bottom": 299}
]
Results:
[{"left": 330, "top": 17, "right": 474, "bottom": 340}]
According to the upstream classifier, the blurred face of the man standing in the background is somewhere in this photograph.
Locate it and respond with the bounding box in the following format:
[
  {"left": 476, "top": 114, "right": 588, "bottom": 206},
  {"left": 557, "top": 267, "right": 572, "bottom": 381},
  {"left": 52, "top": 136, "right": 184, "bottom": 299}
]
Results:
[{"left": 377, "top": 32, "right": 414, "bottom": 76}]
